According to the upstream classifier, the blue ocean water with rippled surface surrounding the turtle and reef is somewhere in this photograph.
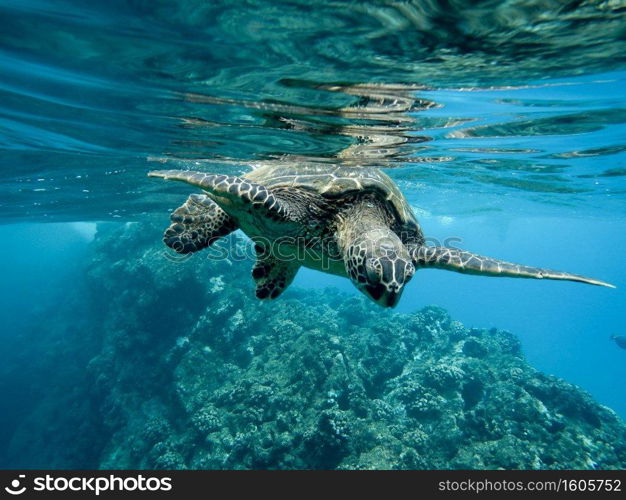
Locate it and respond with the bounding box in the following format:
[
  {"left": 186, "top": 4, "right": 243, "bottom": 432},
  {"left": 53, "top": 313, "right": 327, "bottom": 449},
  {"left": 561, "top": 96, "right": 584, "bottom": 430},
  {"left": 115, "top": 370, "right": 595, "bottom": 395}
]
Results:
[{"left": 0, "top": 0, "right": 626, "bottom": 467}]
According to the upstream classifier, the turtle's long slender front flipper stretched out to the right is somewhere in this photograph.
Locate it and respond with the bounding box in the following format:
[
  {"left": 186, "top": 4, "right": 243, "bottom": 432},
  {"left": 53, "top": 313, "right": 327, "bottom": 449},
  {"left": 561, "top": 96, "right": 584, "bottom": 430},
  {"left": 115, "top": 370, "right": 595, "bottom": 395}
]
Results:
[{"left": 409, "top": 245, "right": 615, "bottom": 288}]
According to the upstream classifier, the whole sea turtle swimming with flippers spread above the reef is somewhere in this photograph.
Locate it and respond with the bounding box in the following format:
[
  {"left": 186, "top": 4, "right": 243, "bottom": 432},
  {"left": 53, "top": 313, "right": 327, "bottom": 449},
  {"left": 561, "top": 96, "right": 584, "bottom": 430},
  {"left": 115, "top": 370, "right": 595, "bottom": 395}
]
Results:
[{"left": 148, "top": 164, "right": 613, "bottom": 307}]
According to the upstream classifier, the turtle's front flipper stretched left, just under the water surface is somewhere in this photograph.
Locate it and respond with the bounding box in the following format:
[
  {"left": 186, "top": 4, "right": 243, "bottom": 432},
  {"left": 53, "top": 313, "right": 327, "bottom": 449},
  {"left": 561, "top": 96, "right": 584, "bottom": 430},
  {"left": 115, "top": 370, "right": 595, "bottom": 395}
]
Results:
[{"left": 148, "top": 170, "right": 289, "bottom": 220}]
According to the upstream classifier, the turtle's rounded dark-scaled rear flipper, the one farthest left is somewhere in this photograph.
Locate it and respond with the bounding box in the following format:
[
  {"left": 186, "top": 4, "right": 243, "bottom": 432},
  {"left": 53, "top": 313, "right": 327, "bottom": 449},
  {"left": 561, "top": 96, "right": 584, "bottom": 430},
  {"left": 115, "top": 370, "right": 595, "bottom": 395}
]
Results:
[{"left": 163, "top": 194, "right": 237, "bottom": 254}]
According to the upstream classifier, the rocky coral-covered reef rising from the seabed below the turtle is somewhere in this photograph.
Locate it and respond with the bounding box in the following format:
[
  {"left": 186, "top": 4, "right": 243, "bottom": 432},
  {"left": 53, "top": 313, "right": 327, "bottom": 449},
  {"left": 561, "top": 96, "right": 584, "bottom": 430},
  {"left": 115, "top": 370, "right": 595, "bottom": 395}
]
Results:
[{"left": 4, "top": 224, "right": 626, "bottom": 469}]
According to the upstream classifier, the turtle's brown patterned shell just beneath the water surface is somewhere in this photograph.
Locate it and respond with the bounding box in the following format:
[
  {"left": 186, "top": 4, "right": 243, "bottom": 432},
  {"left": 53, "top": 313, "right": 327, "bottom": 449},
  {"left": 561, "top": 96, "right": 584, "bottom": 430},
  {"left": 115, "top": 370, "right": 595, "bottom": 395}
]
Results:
[{"left": 244, "top": 164, "right": 421, "bottom": 235}]
